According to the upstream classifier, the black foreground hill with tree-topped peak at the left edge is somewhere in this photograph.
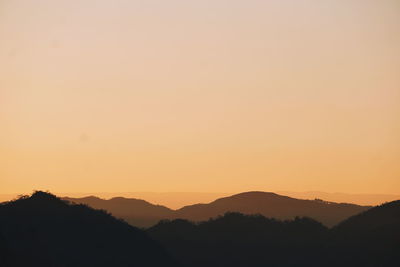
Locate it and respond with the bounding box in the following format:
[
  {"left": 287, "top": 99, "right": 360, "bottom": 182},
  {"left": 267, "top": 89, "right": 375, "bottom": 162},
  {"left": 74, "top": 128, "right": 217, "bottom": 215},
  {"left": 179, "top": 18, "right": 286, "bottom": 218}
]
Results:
[{"left": 0, "top": 192, "right": 176, "bottom": 267}]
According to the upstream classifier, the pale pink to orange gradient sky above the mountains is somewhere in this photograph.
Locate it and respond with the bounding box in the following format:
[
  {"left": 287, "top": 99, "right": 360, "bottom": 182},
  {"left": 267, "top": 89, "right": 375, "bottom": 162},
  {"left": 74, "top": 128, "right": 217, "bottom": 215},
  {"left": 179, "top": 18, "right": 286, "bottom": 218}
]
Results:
[{"left": 0, "top": 0, "right": 400, "bottom": 194}]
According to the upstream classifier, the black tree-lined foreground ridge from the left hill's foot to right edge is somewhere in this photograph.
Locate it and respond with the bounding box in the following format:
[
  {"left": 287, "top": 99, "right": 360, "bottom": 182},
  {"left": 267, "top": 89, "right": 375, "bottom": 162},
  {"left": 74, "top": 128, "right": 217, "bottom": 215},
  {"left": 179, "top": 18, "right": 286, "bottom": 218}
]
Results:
[{"left": 147, "top": 201, "right": 400, "bottom": 267}]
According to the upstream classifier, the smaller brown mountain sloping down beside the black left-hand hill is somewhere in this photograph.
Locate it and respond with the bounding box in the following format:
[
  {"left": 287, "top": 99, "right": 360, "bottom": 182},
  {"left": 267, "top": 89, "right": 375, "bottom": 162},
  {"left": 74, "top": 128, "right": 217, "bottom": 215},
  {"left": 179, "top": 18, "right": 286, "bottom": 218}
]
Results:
[{"left": 63, "top": 196, "right": 173, "bottom": 227}]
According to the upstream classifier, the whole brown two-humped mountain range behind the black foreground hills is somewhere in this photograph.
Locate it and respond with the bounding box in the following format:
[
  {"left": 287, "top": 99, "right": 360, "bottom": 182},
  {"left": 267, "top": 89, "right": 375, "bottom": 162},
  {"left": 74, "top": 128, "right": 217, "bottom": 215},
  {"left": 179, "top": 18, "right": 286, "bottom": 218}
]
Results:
[{"left": 64, "top": 192, "right": 370, "bottom": 227}]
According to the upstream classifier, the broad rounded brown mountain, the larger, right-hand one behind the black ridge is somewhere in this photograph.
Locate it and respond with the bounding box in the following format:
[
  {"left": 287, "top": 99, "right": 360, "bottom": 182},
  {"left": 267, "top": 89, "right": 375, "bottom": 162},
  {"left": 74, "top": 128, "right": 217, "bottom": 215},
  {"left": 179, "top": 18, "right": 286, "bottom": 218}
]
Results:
[{"left": 174, "top": 192, "right": 370, "bottom": 226}]
